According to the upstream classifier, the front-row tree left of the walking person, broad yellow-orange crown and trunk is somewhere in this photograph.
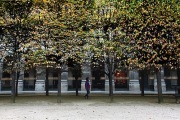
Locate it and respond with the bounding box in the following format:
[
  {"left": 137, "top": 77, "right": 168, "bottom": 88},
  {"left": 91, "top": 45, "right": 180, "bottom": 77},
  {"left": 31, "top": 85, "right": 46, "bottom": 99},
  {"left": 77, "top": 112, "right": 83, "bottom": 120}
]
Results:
[{"left": 24, "top": 0, "right": 95, "bottom": 102}]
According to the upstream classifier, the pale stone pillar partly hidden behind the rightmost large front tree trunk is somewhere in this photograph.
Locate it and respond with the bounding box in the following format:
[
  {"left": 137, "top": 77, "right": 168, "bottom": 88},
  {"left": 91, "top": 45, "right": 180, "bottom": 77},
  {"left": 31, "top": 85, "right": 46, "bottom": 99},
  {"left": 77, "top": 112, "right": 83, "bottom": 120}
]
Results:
[{"left": 154, "top": 68, "right": 166, "bottom": 92}]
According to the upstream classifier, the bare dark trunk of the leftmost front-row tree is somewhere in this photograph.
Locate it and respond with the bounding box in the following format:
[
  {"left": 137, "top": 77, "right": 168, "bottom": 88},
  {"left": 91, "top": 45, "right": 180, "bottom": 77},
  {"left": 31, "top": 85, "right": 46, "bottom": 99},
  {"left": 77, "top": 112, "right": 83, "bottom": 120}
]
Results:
[{"left": 11, "top": 71, "right": 17, "bottom": 103}]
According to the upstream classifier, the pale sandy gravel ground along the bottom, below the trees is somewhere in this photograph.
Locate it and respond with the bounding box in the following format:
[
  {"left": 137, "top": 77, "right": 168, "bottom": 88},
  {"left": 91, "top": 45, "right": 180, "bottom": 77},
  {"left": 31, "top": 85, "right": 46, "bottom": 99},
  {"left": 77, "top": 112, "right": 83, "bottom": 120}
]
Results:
[{"left": 0, "top": 95, "right": 180, "bottom": 120}]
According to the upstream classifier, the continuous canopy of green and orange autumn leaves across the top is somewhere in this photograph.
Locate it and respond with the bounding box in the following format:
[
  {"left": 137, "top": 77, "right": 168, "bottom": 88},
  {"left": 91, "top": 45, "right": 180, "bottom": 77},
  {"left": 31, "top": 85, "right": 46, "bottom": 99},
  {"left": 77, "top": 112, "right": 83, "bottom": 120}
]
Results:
[{"left": 0, "top": 0, "right": 180, "bottom": 69}]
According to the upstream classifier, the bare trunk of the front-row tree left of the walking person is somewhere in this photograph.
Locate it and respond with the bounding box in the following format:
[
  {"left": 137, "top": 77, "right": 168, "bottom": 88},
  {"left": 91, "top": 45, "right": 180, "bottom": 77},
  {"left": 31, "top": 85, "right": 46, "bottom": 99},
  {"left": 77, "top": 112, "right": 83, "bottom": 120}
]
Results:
[{"left": 57, "top": 68, "right": 61, "bottom": 103}]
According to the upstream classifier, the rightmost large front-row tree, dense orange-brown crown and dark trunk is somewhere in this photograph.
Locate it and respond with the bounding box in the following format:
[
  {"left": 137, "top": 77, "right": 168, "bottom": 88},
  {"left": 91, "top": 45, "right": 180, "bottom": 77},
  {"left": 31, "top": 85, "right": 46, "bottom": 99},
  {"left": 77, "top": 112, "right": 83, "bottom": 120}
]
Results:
[{"left": 120, "top": 0, "right": 180, "bottom": 103}]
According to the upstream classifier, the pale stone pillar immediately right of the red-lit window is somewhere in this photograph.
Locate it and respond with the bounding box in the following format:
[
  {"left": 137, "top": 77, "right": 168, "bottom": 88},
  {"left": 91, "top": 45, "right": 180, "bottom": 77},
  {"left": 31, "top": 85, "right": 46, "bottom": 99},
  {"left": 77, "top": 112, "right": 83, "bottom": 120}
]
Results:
[{"left": 129, "top": 70, "right": 140, "bottom": 92}]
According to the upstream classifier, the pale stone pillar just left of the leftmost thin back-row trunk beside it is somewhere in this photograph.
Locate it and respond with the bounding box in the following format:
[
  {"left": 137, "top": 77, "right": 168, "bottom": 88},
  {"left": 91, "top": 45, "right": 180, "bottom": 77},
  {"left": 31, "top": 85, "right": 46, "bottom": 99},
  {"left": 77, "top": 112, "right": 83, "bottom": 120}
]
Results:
[{"left": 35, "top": 67, "right": 46, "bottom": 91}]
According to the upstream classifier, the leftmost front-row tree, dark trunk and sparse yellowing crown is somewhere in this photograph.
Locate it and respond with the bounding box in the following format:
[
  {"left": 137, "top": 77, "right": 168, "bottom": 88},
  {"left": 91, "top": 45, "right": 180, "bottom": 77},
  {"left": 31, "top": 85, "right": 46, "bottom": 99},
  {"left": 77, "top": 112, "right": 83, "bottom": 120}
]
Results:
[{"left": 0, "top": 0, "right": 32, "bottom": 102}]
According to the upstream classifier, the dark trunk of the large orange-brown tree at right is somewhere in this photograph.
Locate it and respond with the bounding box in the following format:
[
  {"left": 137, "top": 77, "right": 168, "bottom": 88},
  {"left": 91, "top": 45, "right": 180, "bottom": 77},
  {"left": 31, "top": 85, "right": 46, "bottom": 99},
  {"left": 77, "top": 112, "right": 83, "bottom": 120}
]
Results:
[{"left": 156, "top": 69, "right": 163, "bottom": 103}]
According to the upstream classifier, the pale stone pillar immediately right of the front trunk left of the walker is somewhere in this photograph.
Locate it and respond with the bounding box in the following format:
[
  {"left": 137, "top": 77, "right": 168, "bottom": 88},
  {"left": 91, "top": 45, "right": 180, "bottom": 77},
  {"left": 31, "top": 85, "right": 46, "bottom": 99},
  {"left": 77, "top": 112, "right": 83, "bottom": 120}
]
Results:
[{"left": 61, "top": 72, "right": 68, "bottom": 92}]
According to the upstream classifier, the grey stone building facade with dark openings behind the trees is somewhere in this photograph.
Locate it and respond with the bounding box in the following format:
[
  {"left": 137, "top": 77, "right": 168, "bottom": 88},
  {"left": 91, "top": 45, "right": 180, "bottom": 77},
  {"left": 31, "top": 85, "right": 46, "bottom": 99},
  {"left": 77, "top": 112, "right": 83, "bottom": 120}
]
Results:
[{"left": 0, "top": 58, "right": 178, "bottom": 94}]
